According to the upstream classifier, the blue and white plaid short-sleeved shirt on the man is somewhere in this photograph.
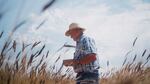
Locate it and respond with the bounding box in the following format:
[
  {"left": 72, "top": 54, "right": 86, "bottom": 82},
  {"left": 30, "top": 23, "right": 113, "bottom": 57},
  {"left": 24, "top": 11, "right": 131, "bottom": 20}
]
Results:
[{"left": 73, "top": 34, "right": 99, "bottom": 73}]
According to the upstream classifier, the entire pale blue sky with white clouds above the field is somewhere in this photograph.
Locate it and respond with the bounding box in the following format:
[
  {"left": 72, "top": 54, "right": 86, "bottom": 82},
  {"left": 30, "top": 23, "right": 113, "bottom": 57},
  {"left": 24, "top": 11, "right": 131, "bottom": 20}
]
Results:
[{"left": 0, "top": 0, "right": 150, "bottom": 70}]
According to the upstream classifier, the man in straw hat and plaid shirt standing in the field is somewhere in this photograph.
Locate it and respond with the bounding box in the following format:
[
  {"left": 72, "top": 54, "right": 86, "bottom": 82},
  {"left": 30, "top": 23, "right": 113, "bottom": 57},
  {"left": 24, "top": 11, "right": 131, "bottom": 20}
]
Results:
[{"left": 63, "top": 23, "right": 99, "bottom": 84}]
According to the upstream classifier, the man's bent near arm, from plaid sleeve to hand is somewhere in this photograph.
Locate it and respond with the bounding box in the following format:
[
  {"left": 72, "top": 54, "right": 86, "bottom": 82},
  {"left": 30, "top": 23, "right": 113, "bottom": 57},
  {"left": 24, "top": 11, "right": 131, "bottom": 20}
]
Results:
[{"left": 64, "top": 38, "right": 97, "bottom": 66}]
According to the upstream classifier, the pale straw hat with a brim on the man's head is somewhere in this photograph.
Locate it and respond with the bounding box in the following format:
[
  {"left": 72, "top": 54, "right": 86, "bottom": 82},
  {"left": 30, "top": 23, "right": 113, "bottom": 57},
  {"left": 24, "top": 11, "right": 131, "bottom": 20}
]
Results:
[{"left": 65, "top": 23, "right": 85, "bottom": 36}]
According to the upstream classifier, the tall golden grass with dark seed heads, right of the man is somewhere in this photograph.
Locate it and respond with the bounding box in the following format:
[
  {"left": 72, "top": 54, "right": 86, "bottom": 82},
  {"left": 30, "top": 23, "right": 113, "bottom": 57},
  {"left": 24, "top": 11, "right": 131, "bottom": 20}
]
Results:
[{"left": 100, "top": 37, "right": 150, "bottom": 84}]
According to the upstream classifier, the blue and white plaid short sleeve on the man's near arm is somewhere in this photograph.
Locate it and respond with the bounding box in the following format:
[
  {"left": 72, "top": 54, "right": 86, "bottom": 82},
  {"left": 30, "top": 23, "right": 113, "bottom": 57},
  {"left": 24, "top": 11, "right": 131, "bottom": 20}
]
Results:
[{"left": 82, "top": 37, "right": 97, "bottom": 55}]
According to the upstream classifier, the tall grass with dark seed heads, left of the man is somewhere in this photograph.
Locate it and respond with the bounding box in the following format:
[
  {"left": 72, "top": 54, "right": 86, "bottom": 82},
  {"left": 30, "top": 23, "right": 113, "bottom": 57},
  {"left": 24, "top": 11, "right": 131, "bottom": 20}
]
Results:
[{"left": 0, "top": 32, "right": 73, "bottom": 84}]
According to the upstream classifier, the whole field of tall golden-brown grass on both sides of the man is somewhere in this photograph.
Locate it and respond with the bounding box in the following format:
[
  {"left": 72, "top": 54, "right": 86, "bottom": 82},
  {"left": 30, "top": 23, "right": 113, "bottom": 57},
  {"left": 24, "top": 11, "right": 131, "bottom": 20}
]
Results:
[{"left": 0, "top": 31, "right": 150, "bottom": 84}]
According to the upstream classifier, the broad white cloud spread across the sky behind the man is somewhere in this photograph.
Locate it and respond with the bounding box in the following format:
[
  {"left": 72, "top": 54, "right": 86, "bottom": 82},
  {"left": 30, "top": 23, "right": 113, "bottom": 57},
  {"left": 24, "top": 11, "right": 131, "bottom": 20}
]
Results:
[{"left": 13, "top": 0, "right": 150, "bottom": 69}]
